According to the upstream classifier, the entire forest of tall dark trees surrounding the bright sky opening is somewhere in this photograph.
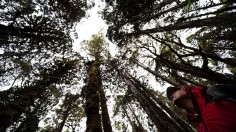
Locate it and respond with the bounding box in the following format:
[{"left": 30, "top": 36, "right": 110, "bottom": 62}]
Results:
[{"left": 0, "top": 0, "right": 236, "bottom": 132}]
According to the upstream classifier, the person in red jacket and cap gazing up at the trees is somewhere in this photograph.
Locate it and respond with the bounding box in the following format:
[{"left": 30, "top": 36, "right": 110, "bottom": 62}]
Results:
[{"left": 166, "top": 86, "right": 236, "bottom": 132}]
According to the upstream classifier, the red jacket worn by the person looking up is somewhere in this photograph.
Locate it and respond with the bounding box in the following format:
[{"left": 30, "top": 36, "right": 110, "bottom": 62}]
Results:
[{"left": 179, "top": 86, "right": 236, "bottom": 132}]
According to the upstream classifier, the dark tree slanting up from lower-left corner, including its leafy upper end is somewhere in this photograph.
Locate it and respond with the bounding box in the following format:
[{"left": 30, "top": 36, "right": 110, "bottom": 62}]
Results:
[{"left": 0, "top": 60, "right": 77, "bottom": 131}]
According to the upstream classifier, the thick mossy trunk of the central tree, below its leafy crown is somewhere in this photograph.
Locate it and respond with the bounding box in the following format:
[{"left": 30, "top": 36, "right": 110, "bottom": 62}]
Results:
[{"left": 85, "top": 61, "right": 102, "bottom": 132}]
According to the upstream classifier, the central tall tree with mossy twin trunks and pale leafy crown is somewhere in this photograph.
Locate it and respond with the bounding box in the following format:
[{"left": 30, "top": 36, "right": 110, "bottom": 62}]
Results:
[{"left": 83, "top": 34, "right": 112, "bottom": 132}]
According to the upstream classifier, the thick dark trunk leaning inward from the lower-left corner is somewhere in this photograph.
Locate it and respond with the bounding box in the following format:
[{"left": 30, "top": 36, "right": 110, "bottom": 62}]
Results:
[{"left": 0, "top": 60, "right": 72, "bottom": 132}]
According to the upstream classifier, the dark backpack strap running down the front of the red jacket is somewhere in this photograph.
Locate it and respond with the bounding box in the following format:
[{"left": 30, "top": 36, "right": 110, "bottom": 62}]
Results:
[{"left": 189, "top": 90, "right": 209, "bottom": 132}]
